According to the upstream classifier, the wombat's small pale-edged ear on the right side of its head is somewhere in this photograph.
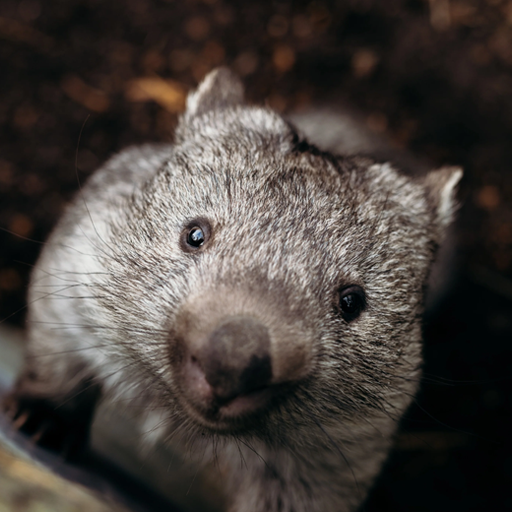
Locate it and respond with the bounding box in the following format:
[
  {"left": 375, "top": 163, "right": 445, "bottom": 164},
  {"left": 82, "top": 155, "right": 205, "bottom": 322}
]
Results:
[{"left": 425, "top": 167, "right": 462, "bottom": 236}]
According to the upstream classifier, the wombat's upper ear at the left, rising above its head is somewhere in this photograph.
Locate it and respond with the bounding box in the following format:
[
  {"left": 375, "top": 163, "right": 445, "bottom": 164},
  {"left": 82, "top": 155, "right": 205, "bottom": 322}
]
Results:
[{"left": 185, "top": 68, "right": 244, "bottom": 119}]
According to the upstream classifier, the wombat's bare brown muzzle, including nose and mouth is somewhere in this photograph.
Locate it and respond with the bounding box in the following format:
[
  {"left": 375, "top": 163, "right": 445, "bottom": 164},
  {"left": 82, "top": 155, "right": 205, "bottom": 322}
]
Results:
[{"left": 169, "top": 288, "right": 311, "bottom": 428}]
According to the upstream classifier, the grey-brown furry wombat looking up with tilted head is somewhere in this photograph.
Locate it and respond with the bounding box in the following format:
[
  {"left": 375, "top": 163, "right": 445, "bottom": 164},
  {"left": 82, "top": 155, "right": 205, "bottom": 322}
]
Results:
[{"left": 6, "top": 69, "right": 462, "bottom": 512}]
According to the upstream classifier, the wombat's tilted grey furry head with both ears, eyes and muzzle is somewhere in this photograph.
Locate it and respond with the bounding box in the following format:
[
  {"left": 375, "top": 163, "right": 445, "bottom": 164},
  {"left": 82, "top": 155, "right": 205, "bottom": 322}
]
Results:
[{"left": 102, "top": 69, "right": 461, "bottom": 438}]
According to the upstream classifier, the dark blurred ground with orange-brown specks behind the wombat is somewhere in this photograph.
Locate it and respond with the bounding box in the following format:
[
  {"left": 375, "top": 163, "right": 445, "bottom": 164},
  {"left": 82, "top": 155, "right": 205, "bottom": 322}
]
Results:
[{"left": 0, "top": 0, "right": 512, "bottom": 512}]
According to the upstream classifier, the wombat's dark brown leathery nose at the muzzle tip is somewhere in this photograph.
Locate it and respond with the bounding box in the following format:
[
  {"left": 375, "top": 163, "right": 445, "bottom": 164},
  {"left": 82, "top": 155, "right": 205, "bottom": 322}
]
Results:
[{"left": 192, "top": 316, "right": 272, "bottom": 402}]
